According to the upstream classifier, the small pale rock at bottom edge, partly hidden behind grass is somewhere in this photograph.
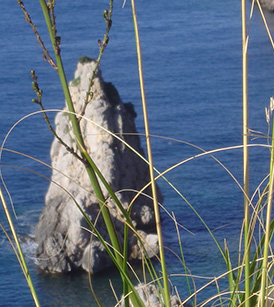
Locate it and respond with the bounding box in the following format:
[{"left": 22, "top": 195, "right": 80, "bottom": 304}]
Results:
[{"left": 120, "top": 283, "right": 182, "bottom": 307}]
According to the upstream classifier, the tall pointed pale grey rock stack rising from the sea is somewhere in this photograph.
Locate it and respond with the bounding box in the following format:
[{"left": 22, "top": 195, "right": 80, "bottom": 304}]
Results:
[{"left": 36, "top": 58, "right": 162, "bottom": 273}]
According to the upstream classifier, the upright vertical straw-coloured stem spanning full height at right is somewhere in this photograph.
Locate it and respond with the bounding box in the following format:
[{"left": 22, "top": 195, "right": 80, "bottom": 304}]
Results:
[{"left": 242, "top": 0, "right": 250, "bottom": 307}]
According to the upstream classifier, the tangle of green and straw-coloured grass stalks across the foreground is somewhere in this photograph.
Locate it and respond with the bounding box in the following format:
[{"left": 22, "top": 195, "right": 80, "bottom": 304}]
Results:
[{"left": 0, "top": 0, "right": 274, "bottom": 307}]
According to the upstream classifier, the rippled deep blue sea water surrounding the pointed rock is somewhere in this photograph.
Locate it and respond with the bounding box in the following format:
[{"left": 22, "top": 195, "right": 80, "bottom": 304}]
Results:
[{"left": 0, "top": 0, "right": 274, "bottom": 306}]
